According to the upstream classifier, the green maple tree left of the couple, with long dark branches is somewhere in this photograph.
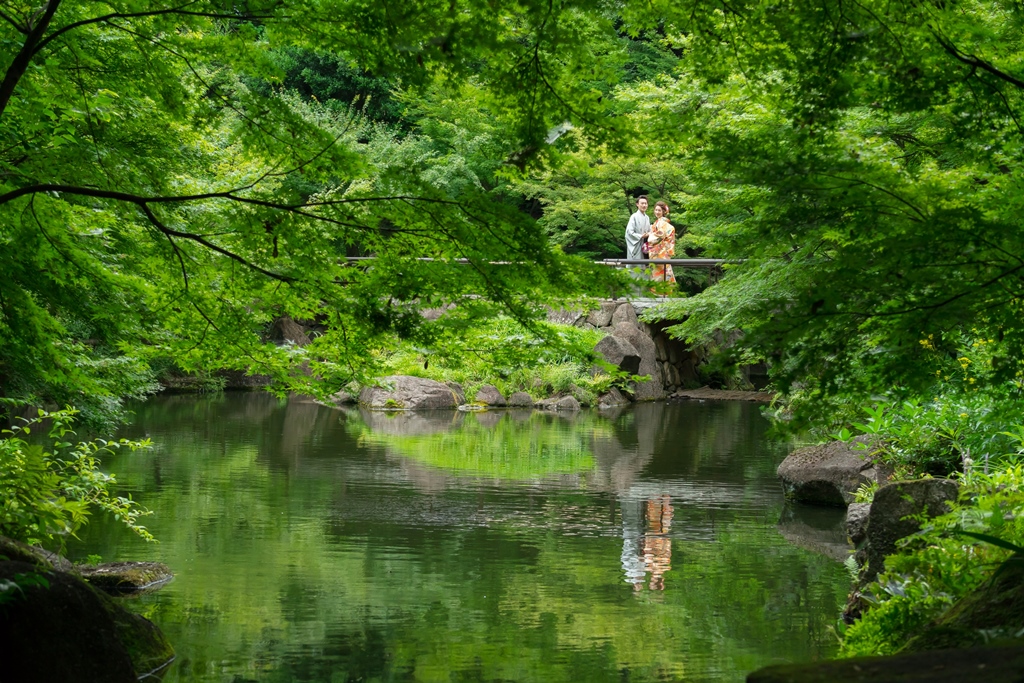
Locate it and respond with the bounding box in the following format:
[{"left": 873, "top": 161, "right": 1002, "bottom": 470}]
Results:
[{"left": 0, "top": 0, "right": 622, "bottom": 423}]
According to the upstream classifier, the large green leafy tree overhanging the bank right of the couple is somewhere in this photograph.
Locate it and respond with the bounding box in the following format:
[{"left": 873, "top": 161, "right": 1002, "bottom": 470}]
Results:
[{"left": 622, "top": 2, "right": 1024, "bottom": 421}]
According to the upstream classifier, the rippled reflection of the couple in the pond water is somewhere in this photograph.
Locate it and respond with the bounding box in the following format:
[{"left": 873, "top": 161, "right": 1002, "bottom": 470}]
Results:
[{"left": 622, "top": 496, "right": 672, "bottom": 591}]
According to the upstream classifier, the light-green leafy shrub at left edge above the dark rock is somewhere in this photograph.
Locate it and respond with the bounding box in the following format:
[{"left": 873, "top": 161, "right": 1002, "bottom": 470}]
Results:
[{"left": 0, "top": 410, "right": 154, "bottom": 546}]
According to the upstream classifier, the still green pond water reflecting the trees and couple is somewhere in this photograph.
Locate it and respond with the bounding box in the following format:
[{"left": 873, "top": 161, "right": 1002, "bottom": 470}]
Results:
[{"left": 72, "top": 393, "right": 849, "bottom": 683}]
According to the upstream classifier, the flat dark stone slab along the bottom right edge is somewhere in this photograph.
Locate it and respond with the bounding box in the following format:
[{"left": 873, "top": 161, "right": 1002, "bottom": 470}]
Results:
[{"left": 746, "top": 646, "right": 1024, "bottom": 683}]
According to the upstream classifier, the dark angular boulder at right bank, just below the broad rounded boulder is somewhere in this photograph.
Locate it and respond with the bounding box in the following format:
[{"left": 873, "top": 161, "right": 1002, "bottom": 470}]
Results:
[{"left": 859, "top": 479, "right": 959, "bottom": 584}]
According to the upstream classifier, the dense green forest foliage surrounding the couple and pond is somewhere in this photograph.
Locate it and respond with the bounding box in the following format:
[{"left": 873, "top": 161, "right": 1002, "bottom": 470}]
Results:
[{"left": 0, "top": 0, "right": 1024, "bottom": 663}]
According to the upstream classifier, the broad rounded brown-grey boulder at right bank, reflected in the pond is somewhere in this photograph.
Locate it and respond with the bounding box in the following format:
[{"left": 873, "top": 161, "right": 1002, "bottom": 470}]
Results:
[{"left": 777, "top": 437, "right": 891, "bottom": 505}]
